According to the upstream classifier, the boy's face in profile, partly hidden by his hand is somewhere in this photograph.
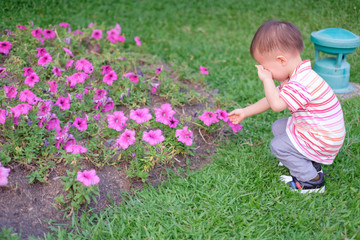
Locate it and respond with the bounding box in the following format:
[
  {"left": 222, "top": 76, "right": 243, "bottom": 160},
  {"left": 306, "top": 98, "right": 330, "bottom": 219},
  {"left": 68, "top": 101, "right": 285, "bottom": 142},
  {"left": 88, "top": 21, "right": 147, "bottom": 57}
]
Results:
[{"left": 254, "top": 51, "right": 289, "bottom": 82}]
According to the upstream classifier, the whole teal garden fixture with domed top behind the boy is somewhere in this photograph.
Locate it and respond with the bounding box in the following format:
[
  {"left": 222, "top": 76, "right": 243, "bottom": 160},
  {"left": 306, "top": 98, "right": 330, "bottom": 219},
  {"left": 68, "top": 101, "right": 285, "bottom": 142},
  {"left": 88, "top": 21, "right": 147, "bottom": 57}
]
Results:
[{"left": 310, "top": 28, "right": 360, "bottom": 93}]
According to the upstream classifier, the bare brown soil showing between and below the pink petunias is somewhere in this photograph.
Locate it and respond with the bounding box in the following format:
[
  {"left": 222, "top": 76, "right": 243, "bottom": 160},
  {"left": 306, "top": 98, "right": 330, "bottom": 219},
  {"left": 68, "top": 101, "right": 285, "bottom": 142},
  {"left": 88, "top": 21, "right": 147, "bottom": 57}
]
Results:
[{"left": 0, "top": 68, "right": 222, "bottom": 239}]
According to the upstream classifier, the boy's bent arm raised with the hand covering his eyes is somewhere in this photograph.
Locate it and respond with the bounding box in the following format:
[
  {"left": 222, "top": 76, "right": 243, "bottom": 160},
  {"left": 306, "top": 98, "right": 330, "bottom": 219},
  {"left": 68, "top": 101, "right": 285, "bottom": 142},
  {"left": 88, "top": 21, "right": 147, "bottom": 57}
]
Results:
[{"left": 256, "top": 65, "right": 288, "bottom": 112}]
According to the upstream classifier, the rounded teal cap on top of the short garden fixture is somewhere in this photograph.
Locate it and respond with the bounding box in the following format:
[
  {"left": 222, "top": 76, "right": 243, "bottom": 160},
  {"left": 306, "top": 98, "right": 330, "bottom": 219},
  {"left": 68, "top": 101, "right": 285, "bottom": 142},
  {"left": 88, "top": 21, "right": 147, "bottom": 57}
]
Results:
[{"left": 310, "top": 28, "right": 360, "bottom": 48}]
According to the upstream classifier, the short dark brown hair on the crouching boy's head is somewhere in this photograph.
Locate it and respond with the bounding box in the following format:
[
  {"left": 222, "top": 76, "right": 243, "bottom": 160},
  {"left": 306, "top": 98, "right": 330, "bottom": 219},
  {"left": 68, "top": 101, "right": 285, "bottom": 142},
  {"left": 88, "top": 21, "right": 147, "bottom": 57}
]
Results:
[{"left": 250, "top": 20, "right": 304, "bottom": 57}]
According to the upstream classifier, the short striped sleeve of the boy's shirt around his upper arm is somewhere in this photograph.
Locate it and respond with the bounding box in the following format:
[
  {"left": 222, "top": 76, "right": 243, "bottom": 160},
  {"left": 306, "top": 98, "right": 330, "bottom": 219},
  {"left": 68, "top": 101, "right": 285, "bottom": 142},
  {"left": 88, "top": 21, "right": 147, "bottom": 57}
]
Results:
[{"left": 280, "top": 81, "right": 312, "bottom": 112}]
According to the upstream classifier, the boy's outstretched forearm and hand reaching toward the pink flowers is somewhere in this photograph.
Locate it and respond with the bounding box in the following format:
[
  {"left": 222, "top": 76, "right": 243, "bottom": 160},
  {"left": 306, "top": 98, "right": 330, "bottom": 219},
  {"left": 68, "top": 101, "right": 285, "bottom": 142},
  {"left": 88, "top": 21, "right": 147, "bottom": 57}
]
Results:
[{"left": 229, "top": 98, "right": 270, "bottom": 124}]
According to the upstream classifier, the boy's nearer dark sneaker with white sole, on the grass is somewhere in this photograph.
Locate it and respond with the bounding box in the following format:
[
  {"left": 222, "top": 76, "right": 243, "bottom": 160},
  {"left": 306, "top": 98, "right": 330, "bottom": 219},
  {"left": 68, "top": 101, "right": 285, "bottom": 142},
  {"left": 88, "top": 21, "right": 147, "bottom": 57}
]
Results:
[{"left": 280, "top": 172, "right": 325, "bottom": 193}]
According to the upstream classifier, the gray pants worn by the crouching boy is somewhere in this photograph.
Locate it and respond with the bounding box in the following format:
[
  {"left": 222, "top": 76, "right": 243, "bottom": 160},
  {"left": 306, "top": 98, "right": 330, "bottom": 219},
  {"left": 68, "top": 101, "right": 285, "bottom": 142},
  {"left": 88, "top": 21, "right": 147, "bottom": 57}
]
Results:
[{"left": 270, "top": 118, "right": 317, "bottom": 181}]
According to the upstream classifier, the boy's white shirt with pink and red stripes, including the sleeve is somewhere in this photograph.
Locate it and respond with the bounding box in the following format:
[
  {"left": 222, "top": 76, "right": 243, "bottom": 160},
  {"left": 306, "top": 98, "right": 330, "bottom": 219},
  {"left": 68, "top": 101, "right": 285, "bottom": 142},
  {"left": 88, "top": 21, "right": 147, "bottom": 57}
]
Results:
[{"left": 279, "top": 60, "right": 345, "bottom": 164}]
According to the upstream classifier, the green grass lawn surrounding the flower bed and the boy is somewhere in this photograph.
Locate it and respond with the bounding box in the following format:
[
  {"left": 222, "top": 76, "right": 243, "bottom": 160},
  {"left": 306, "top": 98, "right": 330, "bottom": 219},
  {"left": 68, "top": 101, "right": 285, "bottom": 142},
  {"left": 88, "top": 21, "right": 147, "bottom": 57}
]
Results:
[{"left": 0, "top": 0, "right": 360, "bottom": 239}]
